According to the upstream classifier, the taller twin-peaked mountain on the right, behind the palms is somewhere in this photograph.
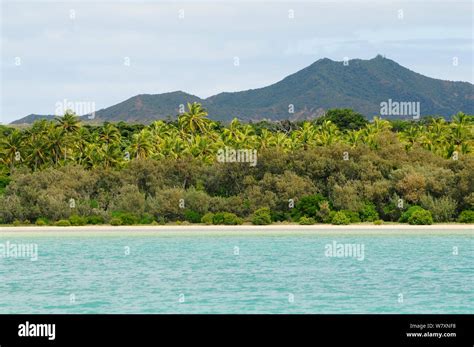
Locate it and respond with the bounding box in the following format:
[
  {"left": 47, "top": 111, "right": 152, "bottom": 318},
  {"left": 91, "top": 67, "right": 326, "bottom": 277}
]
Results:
[{"left": 206, "top": 56, "right": 474, "bottom": 119}]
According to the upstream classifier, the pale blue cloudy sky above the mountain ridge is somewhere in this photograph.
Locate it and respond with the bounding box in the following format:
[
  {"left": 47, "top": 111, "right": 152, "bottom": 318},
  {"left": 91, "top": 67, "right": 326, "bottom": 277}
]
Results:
[{"left": 0, "top": 0, "right": 474, "bottom": 123}]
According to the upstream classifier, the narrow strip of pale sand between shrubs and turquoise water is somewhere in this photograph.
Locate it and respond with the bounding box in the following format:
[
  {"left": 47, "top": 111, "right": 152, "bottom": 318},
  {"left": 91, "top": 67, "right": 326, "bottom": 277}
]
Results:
[{"left": 0, "top": 224, "right": 474, "bottom": 237}]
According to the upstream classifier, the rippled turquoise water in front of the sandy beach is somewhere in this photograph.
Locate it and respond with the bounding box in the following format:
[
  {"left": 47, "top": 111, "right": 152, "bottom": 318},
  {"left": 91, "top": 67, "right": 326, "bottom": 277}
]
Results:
[{"left": 0, "top": 234, "right": 474, "bottom": 313}]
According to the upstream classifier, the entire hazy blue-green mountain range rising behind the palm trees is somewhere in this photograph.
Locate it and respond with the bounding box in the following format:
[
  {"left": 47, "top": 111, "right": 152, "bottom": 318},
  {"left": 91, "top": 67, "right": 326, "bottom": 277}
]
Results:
[{"left": 13, "top": 55, "right": 474, "bottom": 124}]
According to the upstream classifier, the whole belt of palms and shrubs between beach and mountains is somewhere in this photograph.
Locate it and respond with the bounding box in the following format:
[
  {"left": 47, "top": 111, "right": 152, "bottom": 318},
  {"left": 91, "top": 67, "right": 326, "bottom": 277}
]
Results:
[{"left": 0, "top": 104, "right": 474, "bottom": 225}]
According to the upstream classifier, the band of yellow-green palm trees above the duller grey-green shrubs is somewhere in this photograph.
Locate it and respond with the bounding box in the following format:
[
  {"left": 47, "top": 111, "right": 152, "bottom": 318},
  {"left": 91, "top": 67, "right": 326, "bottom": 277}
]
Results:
[{"left": 5, "top": 108, "right": 474, "bottom": 171}]
